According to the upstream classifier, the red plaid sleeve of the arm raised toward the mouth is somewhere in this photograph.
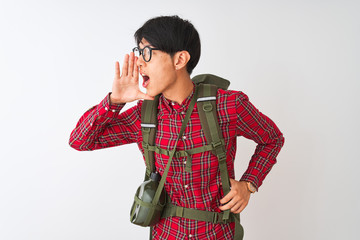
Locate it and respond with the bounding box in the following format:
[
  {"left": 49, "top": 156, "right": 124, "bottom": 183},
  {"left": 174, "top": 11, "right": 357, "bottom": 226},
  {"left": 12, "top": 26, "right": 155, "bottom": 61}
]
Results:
[{"left": 69, "top": 93, "right": 141, "bottom": 151}]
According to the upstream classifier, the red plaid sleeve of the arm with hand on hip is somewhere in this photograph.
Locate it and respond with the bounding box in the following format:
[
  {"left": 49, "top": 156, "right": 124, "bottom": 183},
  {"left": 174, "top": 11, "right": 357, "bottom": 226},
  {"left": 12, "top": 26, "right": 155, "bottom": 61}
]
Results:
[{"left": 236, "top": 92, "right": 284, "bottom": 189}]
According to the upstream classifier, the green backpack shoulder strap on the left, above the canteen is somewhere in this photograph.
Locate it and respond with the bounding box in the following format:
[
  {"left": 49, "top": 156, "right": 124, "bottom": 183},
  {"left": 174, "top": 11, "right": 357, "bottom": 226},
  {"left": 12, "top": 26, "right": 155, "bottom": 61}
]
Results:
[{"left": 141, "top": 96, "right": 159, "bottom": 179}]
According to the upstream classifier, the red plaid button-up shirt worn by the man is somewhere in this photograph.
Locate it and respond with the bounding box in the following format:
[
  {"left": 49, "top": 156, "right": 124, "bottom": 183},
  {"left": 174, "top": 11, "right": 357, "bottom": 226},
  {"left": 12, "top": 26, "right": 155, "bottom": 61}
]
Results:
[{"left": 70, "top": 85, "right": 284, "bottom": 240}]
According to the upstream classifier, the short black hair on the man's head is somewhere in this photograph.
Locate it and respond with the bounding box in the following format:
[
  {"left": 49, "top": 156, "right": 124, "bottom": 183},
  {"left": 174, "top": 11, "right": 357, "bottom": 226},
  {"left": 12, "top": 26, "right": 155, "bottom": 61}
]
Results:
[{"left": 134, "top": 15, "right": 201, "bottom": 74}]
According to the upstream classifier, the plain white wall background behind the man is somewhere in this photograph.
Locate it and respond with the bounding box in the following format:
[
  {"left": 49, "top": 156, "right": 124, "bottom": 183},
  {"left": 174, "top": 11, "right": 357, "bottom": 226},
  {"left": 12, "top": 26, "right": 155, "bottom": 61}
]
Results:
[{"left": 0, "top": 0, "right": 360, "bottom": 240}]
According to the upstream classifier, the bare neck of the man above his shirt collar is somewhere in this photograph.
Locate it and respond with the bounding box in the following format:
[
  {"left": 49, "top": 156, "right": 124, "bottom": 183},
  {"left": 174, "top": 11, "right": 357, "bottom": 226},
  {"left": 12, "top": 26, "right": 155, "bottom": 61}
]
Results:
[{"left": 163, "top": 74, "right": 194, "bottom": 104}]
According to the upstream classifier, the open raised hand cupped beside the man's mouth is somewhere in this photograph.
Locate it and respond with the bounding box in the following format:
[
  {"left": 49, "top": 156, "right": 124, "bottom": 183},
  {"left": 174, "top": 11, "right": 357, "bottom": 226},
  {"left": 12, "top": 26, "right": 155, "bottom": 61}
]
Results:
[{"left": 110, "top": 53, "right": 154, "bottom": 104}]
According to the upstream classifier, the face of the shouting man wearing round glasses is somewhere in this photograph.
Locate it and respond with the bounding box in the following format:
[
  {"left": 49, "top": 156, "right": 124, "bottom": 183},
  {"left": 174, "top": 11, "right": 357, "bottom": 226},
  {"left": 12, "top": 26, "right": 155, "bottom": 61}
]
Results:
[{"left": 136, "top": 38, "right": 176, "bottom": 96}]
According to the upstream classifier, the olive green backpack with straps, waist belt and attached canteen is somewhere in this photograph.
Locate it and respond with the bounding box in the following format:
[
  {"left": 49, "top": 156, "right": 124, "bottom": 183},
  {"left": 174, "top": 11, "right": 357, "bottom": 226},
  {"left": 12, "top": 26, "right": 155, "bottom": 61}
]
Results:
[{"left": 130, "top": 74, "right": 243, "bottom": 240}]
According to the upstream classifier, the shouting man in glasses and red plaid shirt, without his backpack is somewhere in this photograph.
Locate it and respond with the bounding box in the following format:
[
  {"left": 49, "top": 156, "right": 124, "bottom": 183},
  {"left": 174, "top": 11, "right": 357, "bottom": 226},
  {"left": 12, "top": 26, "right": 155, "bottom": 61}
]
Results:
[{"left": 70, "top": 16, "right": 284, "bottom": 240}]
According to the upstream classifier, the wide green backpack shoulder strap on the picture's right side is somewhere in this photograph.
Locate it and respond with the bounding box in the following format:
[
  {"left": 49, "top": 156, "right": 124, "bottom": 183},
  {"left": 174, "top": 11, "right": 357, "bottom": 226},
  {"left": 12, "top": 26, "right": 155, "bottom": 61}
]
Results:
[{"left": 197, "top": 84, "right": 230, "bottom": 220}]
